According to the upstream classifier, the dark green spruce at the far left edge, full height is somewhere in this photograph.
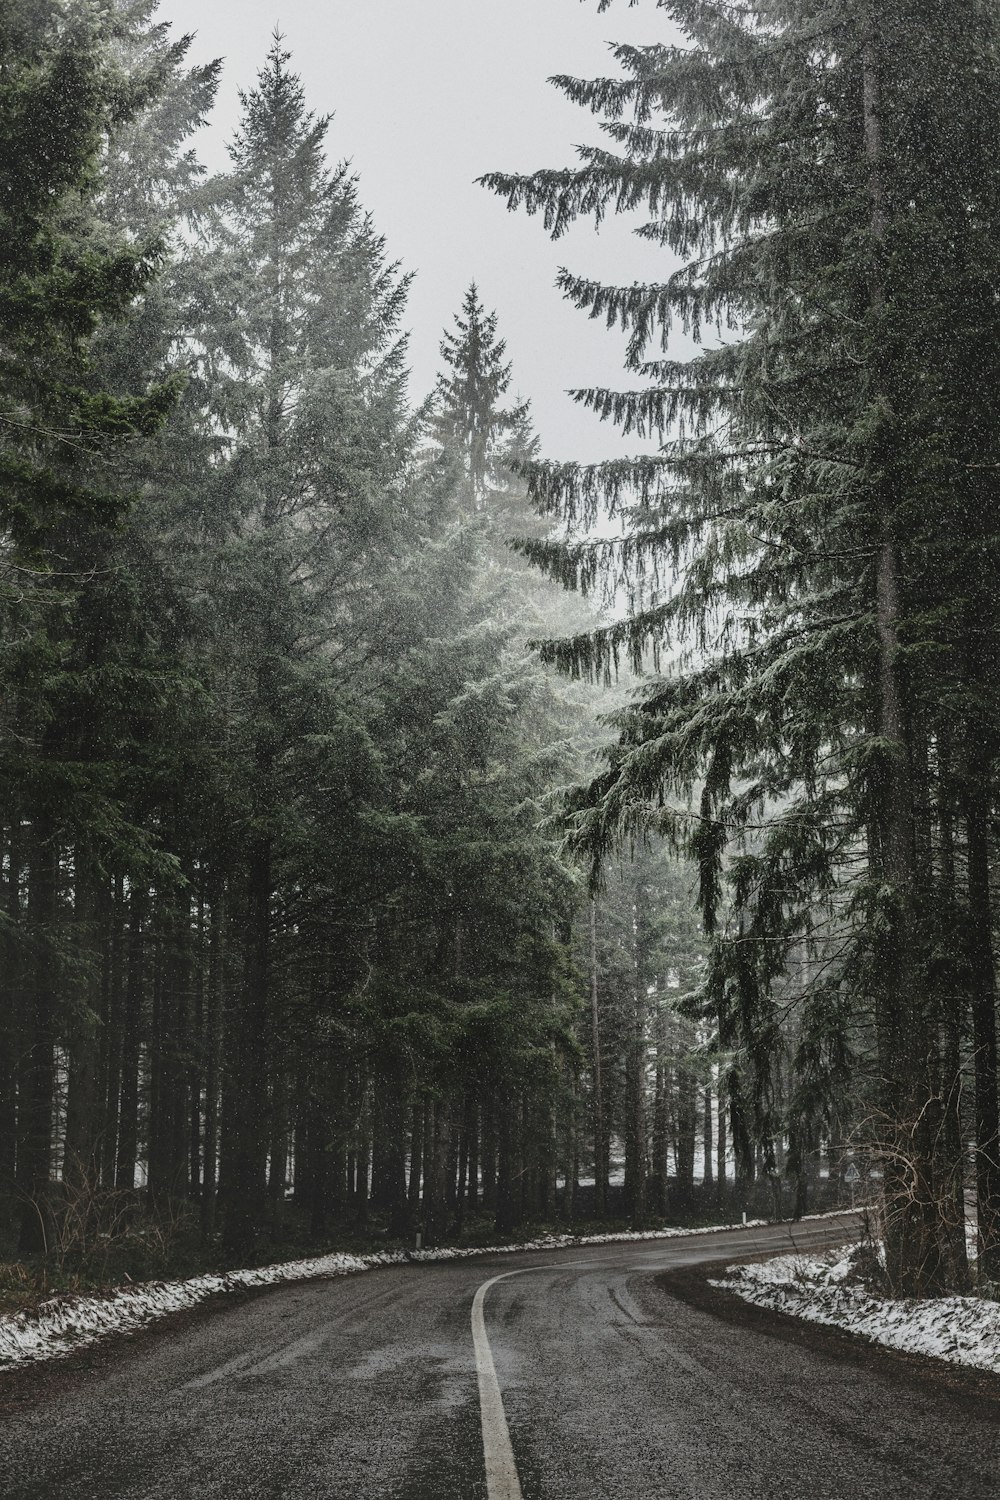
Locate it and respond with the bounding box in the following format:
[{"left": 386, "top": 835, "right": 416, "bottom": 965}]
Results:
[{"left": 0, "top": 0, "right": 177, "bottom": 1250}]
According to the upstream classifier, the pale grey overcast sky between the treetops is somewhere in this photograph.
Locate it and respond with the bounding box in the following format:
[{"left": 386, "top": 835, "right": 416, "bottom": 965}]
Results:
[{"left": 159, "top": 0, "right": 683, "bottom": 462}]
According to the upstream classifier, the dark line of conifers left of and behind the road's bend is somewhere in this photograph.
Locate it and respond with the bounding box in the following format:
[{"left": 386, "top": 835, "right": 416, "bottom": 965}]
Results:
[{"left": 0, "top": 11, "right": 791, "bottom": 1269}]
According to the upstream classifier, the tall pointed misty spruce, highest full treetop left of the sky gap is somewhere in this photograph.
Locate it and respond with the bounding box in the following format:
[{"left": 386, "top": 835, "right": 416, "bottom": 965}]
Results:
[{"left": 194, "top": 38, "right": 411, "bottom": 1247}]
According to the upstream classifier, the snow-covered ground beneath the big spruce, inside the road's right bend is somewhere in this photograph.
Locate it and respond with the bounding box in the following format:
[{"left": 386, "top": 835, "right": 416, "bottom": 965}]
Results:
[{"left": 712, "top": 1250, "right": 1000, "bottom": 1373}]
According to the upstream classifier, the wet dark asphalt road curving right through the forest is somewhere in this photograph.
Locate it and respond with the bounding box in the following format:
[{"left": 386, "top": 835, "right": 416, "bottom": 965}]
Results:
[{"left": 0, "top": 1224, "right": 1000, "bottom": 1500}]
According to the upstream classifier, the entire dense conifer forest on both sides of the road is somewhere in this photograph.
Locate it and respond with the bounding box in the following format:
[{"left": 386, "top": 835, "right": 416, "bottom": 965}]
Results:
[{"left": 0, "top": 0, "right": 1000, "bottom": 1293}]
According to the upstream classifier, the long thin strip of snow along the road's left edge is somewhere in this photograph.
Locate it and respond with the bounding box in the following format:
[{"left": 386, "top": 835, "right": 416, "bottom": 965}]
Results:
[{"left": 0, "top": 1211, "right": 843, "bottom": 1371}]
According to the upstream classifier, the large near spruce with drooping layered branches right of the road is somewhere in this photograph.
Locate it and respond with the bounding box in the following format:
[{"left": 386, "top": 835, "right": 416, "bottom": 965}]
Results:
[{"left": 486, "top": 0, "right": 1000, "bottom": 1293}]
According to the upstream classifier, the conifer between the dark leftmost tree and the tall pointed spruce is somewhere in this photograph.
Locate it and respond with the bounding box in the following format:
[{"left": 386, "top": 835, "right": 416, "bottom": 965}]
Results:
[{"left": 60, "top": 0, "right": 219, "bottom": 1202}]
